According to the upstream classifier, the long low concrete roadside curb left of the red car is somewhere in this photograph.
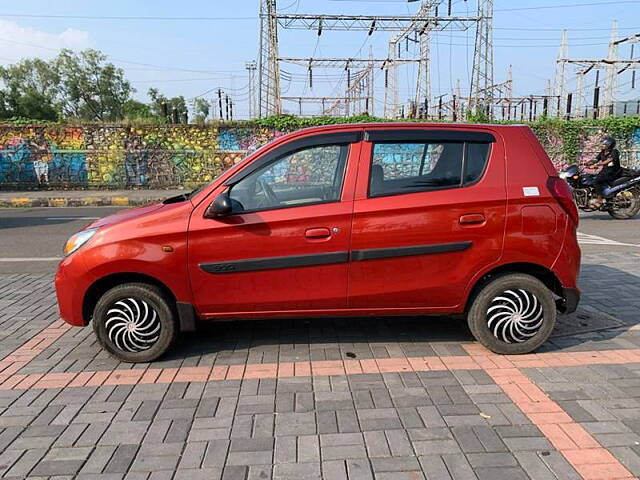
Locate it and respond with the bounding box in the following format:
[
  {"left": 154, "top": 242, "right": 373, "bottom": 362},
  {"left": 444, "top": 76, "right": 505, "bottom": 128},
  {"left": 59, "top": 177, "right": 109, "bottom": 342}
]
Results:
[{"left": 0, "top": 195, "right": 167, "bottom": 208}]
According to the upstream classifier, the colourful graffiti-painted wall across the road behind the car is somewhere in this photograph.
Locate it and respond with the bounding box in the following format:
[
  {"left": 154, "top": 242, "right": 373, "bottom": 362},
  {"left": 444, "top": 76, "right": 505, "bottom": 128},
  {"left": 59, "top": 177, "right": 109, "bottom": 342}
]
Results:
[{"left": 0, "top": 125, "right": 640, "bottom": 190}]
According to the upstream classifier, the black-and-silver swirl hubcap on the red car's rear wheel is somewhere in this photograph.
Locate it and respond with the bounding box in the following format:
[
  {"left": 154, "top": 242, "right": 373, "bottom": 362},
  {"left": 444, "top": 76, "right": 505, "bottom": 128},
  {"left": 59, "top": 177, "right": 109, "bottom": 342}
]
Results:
[{"left": 487, "top": 289, "right": 544, "bottom": 343}]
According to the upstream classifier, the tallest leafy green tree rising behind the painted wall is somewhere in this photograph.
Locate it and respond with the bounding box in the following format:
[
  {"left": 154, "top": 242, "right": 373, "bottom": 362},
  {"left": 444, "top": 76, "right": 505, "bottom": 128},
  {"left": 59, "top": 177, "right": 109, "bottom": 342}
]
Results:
[{"left": 53, "top": 49, "right": 135, "bottom": 121}]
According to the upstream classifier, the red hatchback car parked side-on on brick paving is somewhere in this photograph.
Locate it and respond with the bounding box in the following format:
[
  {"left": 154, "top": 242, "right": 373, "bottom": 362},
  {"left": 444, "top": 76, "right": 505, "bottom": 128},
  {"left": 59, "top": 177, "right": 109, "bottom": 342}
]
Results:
[{"left": 56, "top": 123, "right": 580, "bottom": 362}]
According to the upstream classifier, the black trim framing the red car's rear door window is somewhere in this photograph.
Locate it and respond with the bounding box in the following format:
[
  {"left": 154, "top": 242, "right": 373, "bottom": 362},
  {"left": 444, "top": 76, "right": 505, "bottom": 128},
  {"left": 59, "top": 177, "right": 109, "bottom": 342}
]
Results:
[{"left": 365, "top": 139, "right": 495, "bottom": 198}]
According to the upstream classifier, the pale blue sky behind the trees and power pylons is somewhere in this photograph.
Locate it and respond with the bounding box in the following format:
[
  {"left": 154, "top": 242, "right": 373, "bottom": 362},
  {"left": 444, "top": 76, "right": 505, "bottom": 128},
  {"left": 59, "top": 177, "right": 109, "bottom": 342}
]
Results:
[{"left": 0, "top": 0, "right": 640, "bottom": 118}]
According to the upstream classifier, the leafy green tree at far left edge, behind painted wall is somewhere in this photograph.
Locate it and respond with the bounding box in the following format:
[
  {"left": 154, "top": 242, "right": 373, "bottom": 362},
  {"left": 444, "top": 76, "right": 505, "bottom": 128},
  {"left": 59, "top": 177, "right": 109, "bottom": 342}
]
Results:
[{"left": 0, "top": 59, "right": 60, "bottom": 120}]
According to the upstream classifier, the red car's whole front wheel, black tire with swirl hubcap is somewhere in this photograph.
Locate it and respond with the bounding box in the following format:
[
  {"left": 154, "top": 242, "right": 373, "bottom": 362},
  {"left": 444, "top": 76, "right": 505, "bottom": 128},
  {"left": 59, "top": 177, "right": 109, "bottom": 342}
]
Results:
[{"left": 93, "top": 283, "right": 178, "bottom": 363}]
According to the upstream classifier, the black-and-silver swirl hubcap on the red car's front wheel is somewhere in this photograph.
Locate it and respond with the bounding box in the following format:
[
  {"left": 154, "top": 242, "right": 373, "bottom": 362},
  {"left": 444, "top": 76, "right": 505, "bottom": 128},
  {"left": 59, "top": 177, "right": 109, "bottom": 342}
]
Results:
[{"left": 105, "top": 298, "right": 160, "bottom": 353}]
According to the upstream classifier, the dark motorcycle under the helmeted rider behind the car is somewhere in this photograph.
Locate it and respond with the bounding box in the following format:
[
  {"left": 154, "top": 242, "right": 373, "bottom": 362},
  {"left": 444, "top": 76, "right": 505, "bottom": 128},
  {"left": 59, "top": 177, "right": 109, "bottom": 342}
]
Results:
[{"left": 560, "top": 165, "right": 640, "bottom": 220}]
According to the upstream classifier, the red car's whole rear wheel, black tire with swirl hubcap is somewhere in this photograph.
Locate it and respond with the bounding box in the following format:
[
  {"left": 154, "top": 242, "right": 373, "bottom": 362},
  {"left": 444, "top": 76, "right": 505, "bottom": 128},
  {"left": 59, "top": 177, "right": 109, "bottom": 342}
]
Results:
[{"left": 467, "top": 273, "right": 557, "bottom": 355}]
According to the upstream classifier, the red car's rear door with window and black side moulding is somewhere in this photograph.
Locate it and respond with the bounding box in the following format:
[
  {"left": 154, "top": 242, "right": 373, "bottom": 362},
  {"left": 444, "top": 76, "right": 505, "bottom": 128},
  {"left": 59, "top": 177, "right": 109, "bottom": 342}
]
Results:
[{"left": 349, "top": 127, "right": 506, "bottom": 312}]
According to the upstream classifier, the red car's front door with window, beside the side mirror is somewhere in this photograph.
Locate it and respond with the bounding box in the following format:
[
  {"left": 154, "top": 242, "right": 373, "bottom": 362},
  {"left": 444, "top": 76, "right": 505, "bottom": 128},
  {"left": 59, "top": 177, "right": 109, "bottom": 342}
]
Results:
[{"left": 188, "top": 130, "right": 362, "bottom": 317}]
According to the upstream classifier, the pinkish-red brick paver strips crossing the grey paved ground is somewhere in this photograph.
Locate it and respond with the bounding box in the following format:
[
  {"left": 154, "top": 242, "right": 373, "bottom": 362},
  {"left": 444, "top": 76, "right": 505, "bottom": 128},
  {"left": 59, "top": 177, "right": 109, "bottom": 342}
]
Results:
[{"left": 0, "top": 321, "right": 640, "bottom": 480}]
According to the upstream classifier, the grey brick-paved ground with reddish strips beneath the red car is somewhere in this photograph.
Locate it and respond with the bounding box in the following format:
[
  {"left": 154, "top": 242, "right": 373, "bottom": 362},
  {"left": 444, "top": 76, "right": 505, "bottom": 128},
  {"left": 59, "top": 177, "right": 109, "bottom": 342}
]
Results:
[{"left": 0, "top": 252, "right": 640, "bottom": 480}]
